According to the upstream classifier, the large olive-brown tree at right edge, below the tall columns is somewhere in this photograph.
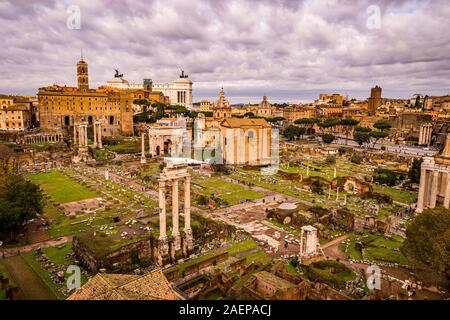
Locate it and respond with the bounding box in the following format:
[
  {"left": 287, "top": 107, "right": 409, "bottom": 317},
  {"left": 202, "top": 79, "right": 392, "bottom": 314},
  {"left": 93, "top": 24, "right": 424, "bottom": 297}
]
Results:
[{"left": 402, "top": 208, "right": 450, "bottom": 279}]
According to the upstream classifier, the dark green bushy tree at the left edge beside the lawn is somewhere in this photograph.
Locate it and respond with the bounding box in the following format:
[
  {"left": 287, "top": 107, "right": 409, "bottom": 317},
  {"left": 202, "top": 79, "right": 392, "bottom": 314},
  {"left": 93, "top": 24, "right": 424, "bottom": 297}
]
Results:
[{"left": 0, "top": 175, "right": 43, "bottom": 240}]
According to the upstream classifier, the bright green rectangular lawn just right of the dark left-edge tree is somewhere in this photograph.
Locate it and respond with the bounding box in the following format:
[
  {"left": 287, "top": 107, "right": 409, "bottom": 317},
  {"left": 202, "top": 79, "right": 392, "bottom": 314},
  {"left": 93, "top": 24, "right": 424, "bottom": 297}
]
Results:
[{"left": 28, "top": 171, "right": 99, "bottom": 203}]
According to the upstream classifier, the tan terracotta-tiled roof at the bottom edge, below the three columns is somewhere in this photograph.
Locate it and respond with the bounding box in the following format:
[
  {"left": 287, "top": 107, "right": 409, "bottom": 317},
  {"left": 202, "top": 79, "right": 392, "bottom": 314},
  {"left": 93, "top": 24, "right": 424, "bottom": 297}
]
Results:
[{"left": 68, "top": 269, "right": 183, "bottom": 300}]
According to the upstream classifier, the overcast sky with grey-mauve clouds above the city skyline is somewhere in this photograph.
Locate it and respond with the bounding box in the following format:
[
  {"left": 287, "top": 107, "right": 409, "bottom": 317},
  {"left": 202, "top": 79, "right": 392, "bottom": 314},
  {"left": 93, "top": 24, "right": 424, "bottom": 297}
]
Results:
[{"left": 0, "top": 0, "right": 450, "bottom": 102}]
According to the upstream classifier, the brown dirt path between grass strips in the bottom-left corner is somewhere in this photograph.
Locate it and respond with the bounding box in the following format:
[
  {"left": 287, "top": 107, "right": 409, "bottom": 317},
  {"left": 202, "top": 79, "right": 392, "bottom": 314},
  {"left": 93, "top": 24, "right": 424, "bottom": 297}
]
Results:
[{"left": 1, "top": 256, "right": 56, "bottom": 300}]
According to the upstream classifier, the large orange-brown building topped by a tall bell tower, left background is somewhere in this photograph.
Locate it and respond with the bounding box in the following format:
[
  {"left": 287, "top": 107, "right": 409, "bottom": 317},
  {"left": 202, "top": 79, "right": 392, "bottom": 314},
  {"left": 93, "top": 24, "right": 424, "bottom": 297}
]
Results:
[{"left": 38, "top": 58, "right": 134, "bottom": 136}]
